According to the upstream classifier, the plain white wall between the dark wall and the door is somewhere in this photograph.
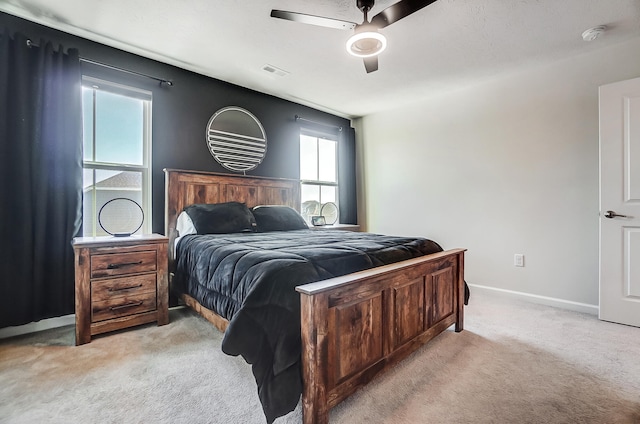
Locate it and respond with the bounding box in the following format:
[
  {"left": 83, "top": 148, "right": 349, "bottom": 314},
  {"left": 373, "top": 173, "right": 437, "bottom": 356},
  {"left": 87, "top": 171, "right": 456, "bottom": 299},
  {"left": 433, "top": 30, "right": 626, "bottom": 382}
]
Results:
[{"left": 355, "top": 38, "right": 640, "bottom": 309}]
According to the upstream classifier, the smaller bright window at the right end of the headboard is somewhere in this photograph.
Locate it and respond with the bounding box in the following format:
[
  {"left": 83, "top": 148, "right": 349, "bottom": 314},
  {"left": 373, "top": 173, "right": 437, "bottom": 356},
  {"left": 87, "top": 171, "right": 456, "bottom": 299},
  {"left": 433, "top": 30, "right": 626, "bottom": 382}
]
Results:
[{"left": 300, "top": 132, "right": 338, "bottom": 223}]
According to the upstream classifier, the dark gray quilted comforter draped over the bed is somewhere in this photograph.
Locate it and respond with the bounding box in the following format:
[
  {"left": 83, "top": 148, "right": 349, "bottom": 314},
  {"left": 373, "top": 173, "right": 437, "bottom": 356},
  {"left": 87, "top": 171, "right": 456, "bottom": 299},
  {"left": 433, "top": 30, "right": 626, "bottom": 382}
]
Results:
[{"left": 173, "top": 230, "right": 442, "bottom": 423}]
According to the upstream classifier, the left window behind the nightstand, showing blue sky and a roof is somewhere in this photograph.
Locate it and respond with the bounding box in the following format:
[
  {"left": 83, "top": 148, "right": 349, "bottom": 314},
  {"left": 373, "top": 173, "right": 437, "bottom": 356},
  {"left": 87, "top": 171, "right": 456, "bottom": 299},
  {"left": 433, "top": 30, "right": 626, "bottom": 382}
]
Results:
[{"left": 82, "top": 77, "right": 151, "bottom": 236}]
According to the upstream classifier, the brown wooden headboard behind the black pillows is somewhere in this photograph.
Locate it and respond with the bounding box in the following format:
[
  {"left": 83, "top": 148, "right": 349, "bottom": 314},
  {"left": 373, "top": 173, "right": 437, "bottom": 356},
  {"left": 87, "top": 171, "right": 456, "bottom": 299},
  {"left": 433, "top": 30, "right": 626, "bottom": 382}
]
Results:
[{"left": 164, "top": 169, "right": 300, "bottom": 240}]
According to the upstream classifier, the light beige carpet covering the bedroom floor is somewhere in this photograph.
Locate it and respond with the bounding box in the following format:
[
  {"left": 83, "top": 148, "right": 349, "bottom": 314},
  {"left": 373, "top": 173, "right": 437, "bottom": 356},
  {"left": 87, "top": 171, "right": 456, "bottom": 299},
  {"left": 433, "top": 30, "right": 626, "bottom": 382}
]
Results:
[{"left": 0, "top": 293, "right": 640, "bottom": 424}]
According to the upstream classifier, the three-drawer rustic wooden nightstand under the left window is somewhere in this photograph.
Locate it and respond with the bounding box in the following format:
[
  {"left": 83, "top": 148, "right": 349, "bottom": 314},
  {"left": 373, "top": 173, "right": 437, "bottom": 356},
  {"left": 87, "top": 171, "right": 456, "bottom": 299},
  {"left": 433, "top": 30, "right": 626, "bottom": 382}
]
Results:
[{"left": 73, "top": 234, "right": 169, "bottom": 345}]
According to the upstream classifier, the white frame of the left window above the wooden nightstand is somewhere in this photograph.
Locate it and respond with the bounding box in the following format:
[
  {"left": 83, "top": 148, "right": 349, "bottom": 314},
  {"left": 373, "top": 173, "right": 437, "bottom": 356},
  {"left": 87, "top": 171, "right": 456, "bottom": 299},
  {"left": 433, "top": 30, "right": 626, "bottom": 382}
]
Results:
[{"left": 82, "top": 75, "right": 153, "bottom": 236}]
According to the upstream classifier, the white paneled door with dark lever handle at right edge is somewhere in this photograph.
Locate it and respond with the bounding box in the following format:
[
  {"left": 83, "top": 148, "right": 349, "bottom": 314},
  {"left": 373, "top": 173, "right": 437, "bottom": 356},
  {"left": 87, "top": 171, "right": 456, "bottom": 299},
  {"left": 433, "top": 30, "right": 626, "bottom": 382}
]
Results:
[{"left": 600, "top": 78, "right": 640, "bottom": 327}]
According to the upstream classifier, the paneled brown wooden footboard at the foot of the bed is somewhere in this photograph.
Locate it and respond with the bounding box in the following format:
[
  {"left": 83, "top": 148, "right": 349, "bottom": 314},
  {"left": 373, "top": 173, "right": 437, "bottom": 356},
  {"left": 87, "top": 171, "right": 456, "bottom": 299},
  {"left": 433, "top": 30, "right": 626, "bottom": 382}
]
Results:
[{"left": 297, "top": 249, "right": 465, "bottom": 424}]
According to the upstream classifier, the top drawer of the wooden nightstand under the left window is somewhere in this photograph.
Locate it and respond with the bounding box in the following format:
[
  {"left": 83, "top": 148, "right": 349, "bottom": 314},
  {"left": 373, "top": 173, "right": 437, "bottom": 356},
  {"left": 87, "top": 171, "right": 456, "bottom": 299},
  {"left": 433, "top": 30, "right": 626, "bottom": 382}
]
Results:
[{"left": 91, "top": 249, "right": 157, "bottom": 278}]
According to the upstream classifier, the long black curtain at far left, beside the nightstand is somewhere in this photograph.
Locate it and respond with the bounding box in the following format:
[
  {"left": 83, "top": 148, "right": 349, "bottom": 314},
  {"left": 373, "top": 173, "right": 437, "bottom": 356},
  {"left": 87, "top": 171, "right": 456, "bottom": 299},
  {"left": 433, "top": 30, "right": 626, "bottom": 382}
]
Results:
[{"left": 0, "top": 30, "right": 82, "bottom": 328}]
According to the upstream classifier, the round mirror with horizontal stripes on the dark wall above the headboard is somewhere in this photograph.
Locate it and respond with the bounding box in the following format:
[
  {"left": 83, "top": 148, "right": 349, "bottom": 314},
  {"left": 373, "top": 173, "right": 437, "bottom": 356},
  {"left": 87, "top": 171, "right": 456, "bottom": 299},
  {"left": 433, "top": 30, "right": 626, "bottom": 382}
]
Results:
[{"left": 207, "top": 106, "right": 267, "bottom": 172}]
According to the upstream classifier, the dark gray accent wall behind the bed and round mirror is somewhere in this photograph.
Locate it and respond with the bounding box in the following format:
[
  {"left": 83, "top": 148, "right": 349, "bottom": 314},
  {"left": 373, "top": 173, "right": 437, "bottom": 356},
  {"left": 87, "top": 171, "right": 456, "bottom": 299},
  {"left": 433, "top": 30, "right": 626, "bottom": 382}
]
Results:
[{"left": 0, "top": 12, "right": 357, "bottom": 233}]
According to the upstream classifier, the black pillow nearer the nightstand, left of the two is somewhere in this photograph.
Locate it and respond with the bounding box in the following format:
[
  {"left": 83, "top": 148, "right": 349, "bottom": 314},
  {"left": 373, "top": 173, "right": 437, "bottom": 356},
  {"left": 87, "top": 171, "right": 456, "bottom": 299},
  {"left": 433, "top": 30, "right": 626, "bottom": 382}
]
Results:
[{"left": 184, "top": 202, "right": 256, "bottom": 234}]
